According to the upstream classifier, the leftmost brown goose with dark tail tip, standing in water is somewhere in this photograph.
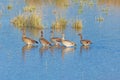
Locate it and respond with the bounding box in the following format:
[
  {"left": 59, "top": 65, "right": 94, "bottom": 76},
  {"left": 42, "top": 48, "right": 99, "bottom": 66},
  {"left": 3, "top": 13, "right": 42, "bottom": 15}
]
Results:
[{"left": 22, "top": 29, "right": 38, "bottom": 45}]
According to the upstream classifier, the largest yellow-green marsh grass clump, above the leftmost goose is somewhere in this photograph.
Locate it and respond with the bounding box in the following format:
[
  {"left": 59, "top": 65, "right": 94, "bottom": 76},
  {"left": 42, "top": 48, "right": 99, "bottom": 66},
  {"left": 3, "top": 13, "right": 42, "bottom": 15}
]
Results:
[{"left": 11, "top": 13, "right": 43, "bottom": 29}]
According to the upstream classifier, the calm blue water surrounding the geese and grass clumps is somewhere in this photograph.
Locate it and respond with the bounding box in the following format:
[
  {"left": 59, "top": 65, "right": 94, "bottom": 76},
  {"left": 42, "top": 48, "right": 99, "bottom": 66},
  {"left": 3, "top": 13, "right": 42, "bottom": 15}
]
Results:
[{"left": 0, "top": 0, "right": 120, "bottom": 80}]
